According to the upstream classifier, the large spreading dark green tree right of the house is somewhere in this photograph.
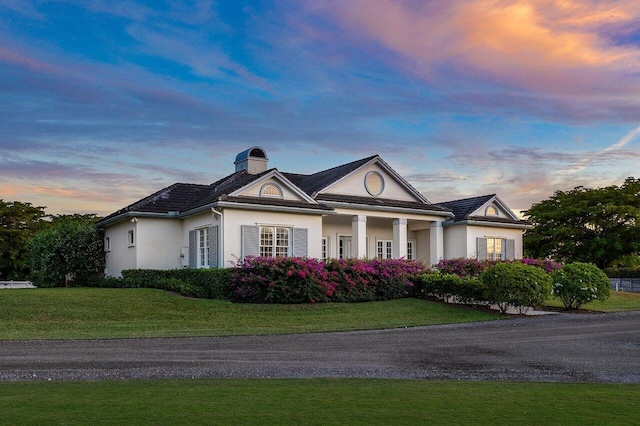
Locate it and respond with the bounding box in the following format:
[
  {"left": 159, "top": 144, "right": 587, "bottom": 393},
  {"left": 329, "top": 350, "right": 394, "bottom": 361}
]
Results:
[{"left": 524, "top": 177, "right": 640, "bottom": 268}]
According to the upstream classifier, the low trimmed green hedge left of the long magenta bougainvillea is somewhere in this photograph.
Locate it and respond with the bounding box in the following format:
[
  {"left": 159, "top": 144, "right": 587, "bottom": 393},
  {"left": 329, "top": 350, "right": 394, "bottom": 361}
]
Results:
[{"left": 89, "top": 268, "right": 231, "bottom": 299}]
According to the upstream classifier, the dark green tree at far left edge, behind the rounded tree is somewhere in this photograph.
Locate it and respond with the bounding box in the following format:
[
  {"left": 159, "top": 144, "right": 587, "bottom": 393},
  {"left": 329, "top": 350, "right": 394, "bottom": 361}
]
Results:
[{"left": 0, "top": 199, "right": 49, "bottom": 279}]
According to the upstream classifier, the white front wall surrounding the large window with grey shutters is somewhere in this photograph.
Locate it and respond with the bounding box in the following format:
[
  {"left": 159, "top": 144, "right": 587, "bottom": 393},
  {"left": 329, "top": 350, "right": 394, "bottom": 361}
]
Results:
[{"left": 221, "top": 208, "right": 322, "bottom": 267}]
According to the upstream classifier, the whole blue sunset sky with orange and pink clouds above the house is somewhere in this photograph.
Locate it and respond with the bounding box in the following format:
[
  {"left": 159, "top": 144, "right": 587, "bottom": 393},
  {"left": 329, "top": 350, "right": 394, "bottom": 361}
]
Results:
[{"left": 0, "top": 0, "right": 640, "bottom": 215}]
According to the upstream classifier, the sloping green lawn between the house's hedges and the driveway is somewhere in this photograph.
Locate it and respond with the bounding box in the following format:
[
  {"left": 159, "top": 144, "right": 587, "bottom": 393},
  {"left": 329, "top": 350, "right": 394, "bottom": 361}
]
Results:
[{"left": 0, "top": 288, "right": 501, "bottom": 340}]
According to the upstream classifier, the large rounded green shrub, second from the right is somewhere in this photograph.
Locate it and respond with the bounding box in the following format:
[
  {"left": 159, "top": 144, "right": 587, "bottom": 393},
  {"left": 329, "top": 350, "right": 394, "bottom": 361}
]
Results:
[{"left": 480, "top": 262, "right": 551, "bottom": 313}]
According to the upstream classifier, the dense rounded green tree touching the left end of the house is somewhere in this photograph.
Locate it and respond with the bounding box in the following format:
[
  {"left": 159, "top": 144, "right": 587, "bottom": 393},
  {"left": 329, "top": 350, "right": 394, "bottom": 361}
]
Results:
[{"left": 29, "top": 215, "right": 105, "bottom": 287}]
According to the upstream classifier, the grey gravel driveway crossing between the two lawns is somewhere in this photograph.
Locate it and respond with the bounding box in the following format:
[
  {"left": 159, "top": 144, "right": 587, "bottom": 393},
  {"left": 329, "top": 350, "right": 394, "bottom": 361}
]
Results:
[{"left": 0, "top": 312, "right": 640, "bottom": 382}]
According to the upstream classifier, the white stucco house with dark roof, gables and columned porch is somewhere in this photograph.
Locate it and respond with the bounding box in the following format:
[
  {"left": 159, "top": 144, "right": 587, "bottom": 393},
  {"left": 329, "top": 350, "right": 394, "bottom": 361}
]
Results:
[{"left": 98, "top": 146, "right": 531, "bottom": 277}]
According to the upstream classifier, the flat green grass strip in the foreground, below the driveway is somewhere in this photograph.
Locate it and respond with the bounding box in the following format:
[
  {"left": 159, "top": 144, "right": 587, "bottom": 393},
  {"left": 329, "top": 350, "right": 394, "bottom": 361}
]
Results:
[{"left": 0, "top": 379, "right": 640, "bottom": 425}]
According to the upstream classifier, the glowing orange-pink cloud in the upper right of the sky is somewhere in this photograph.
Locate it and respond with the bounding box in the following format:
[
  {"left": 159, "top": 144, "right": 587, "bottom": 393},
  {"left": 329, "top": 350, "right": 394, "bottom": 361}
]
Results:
[{"left": 323, "top": 0, "right": 640, "bottom": 95}]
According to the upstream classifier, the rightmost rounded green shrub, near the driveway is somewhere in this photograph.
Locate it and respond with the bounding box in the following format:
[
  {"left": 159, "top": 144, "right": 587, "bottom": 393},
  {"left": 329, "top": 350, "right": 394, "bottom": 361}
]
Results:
[{"left": 551, "top": 262, "right": 611, "bottom": 309}]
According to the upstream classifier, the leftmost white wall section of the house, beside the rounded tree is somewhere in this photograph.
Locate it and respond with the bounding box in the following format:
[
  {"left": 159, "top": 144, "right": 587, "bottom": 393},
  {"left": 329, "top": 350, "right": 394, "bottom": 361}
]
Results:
[{"left": 104, "top": 219, "right": 137, "bottom": 277}]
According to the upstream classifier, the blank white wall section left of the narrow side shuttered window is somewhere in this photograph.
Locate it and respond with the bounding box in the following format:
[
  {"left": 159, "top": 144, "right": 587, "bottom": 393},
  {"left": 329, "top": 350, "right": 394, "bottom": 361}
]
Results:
[{"left": 136, "top": 218, "right": 182, "bottom": 269}]
